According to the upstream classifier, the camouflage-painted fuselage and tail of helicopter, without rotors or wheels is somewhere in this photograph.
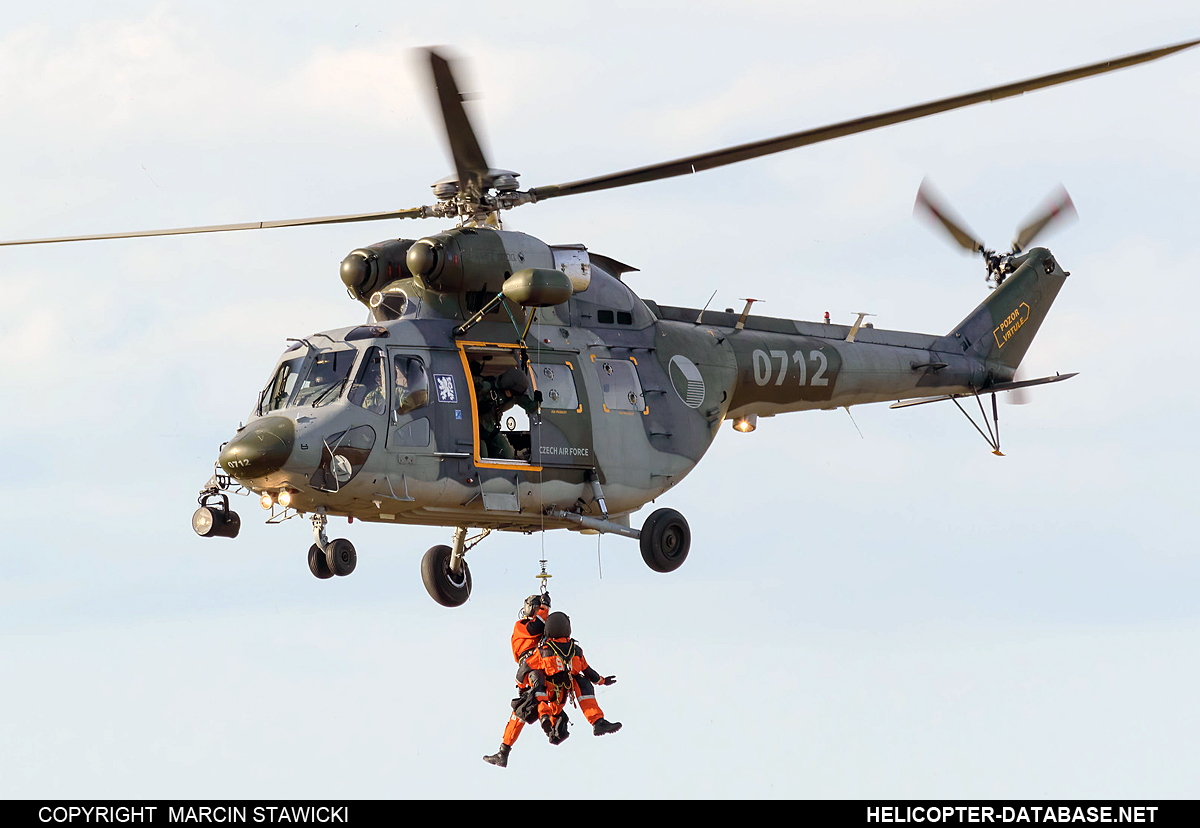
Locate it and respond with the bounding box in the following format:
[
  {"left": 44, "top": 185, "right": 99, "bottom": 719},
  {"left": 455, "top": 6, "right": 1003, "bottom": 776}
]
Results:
[{"left": 220, "top": 227, "right": 1067, "bottom": 532}]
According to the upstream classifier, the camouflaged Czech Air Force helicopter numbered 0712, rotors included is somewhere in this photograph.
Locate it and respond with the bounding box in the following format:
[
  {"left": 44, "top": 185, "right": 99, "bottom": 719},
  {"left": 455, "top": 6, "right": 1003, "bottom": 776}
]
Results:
[{"left": 0, "top": 41, "right": 1200, "bottom": 606}]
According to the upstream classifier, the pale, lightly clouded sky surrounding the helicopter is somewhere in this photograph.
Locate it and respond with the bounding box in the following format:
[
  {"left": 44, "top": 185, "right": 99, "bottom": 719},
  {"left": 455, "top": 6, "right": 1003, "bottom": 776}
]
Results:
[{"left": 0, "top": 0, "right": 1200, "bottom": 798}]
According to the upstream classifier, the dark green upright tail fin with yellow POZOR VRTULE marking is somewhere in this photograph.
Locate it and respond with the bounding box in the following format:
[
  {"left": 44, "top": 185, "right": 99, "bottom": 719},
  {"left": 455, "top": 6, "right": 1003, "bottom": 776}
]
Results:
[{"left": 949, "top": 247, "right": 1067, "bottom": 370}]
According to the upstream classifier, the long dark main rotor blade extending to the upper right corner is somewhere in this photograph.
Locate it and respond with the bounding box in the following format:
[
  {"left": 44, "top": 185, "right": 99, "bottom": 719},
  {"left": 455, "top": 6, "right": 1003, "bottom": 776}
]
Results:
[{"left": 530, "top": 40, "right": 1200, "bottom": 200}]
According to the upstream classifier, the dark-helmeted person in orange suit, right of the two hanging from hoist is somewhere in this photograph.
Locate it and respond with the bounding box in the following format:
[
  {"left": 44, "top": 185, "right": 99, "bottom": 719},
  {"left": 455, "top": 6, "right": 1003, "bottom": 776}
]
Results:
[{"left": 527, "top": 612, "right": 620, "bottom": 745}]
